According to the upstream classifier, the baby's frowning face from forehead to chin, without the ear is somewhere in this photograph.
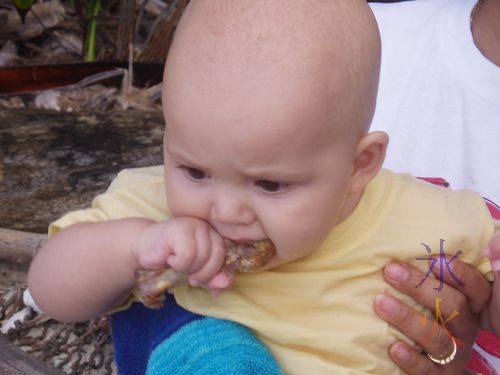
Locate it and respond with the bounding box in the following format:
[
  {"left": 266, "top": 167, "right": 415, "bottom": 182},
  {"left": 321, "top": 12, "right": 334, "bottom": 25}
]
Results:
[{"left": 163, "top": 55, "right": 355, "bottom": 268}]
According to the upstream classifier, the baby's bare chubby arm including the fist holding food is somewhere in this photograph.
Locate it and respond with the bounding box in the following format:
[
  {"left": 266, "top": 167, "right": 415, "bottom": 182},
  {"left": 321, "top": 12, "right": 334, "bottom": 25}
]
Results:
[{"left": 28, "top": 217, "right": 231, "bottom": 321}]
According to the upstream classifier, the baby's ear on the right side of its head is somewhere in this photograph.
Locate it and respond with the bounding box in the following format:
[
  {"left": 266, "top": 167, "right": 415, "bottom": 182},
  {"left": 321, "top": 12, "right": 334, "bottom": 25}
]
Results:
[{"left": 349, "top": 131, "right": 389, "bottom": 194}]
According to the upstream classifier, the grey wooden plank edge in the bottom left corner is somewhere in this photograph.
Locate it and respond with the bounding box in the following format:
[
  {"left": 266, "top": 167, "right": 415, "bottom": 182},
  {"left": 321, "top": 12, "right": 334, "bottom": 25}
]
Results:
[{"left": 0, "top": 335, "right": 63, "bottom": 375}]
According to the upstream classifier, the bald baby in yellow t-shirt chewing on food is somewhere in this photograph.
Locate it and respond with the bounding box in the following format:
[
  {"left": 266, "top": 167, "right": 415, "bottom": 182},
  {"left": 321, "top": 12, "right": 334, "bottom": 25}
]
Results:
[{"left": 28, "top": 0, "right": 499, "bottom": 374}]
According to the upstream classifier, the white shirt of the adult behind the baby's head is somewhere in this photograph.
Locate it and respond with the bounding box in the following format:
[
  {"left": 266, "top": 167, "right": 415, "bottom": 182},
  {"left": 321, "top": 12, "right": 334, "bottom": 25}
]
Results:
[{"left": 371, "top": 0, "right": 500, "bottom": 203}]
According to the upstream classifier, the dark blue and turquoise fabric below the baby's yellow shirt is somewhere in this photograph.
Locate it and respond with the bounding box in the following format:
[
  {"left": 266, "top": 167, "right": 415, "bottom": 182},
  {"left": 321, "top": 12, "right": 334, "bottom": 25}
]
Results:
[{"left": 111, "top": 294, "right": 281, "bottom": 375}]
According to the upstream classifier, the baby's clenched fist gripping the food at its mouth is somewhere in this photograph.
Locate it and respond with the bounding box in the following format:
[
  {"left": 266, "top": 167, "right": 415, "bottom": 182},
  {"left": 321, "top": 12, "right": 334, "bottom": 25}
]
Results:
[{"left": 134, "top": 217, "right": 231, "bottom": 290}]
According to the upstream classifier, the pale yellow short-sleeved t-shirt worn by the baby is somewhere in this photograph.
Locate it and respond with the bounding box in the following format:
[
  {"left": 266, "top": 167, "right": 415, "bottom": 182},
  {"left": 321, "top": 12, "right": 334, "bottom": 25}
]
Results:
[{"left": 50, "top": 167, "right": 500, "bottom": 374}]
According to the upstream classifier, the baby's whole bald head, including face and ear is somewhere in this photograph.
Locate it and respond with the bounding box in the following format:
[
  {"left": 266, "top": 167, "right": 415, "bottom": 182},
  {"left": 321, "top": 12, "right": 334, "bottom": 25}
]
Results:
[{"left": 163, "top": 0, "right": 387, "bottom": 250}]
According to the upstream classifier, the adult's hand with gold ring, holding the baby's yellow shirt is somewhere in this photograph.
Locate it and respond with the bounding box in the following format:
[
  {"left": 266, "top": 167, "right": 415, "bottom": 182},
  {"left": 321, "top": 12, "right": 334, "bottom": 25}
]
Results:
[{"left": 375, "top": 255, "right": 491, "bottom": 375}]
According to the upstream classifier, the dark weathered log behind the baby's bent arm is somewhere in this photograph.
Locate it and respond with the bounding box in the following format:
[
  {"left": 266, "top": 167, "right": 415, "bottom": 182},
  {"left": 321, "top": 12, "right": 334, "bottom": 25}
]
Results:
[{"left": 0, "top": 109, "right": 164, "bottom": 233}]
